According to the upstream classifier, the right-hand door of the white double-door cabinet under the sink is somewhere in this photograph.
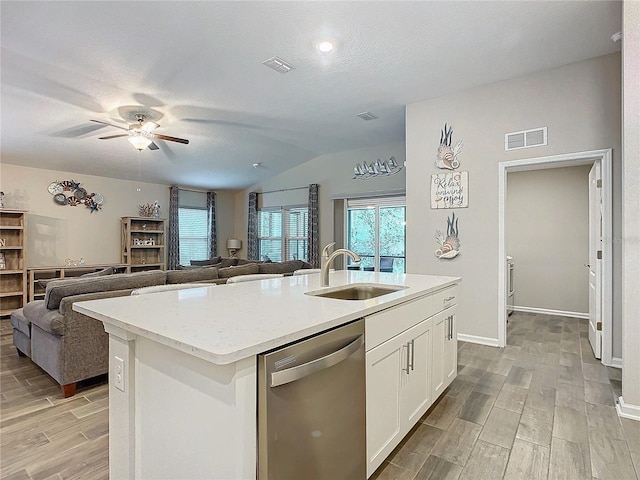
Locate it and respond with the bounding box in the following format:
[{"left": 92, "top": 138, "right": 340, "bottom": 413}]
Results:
[{"left": 400, "top": 320, "right": 431, "bottom": 435}]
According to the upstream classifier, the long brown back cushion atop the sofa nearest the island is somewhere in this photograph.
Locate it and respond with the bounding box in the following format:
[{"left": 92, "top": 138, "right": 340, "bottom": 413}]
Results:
[{"left": 44, "top": 270, "right": 166, "bottom": 310}]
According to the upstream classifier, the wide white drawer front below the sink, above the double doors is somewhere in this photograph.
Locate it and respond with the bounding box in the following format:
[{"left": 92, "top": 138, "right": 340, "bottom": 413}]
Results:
[{"left": 364, "top": 295, "right": 435, "bottom": 351}]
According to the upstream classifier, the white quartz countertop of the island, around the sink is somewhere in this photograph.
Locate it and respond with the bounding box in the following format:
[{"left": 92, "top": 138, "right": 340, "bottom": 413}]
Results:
[{"left": 73, "top": 270, "right": 461, "bottom": 364}]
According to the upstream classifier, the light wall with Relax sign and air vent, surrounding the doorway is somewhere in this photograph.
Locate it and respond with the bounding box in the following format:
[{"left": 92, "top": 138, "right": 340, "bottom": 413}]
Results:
[{"left": 406, "top": 54, "right": 621, "bottom": 346}]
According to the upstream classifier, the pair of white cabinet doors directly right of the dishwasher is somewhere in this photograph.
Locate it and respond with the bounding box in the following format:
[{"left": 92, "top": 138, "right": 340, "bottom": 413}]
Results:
[{"left": 366, "top": 321, "right": 431, "bottom": 476}]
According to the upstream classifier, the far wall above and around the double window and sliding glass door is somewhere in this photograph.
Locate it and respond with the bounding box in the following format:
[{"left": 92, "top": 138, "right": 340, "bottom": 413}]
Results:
[{"left": 235, "top": 142, "right": 405, "bottom": 257}]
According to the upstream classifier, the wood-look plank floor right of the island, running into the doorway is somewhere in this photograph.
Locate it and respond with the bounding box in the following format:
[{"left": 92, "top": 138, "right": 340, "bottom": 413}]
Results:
[{"left": 372, "top": 312, "right": 640, "bottom": 480}]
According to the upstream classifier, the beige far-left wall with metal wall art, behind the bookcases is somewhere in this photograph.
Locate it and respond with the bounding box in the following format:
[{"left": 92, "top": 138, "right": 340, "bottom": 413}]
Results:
[{"left": 0, "top": 163, "right": 235, "bottom": 267}]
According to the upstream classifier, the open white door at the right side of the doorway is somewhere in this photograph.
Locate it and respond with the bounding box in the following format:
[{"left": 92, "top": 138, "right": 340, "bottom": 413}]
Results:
[{"left": 588, "top": 161, "right": 602, "bottom": 358}]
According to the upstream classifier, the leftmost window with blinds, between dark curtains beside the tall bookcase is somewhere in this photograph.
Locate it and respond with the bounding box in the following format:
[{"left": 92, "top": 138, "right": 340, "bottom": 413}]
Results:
[{"left": 178, "top": 207, "right": 209, "bottom": 265}]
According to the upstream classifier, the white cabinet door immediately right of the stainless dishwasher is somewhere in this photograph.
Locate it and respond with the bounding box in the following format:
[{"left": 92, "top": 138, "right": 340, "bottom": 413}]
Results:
[{"left": 366, "top": 335, "right": 406, "bottom": 477}]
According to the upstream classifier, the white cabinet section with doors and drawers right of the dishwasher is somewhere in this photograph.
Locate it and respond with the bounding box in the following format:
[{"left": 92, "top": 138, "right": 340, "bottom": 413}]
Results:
[{"left": 365, "top": 285, "right": 458, "bottom": 477}]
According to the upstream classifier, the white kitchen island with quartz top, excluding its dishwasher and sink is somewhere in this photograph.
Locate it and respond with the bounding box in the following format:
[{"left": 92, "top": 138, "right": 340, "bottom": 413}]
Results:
[{"left": 73, "top": 271, "right": 460, "bottom": 479}]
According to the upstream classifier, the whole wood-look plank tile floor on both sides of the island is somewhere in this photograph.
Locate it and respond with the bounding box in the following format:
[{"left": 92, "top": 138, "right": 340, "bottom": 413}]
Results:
[{"left": 0, "top": 313, "right": 640, "bottom": 480}]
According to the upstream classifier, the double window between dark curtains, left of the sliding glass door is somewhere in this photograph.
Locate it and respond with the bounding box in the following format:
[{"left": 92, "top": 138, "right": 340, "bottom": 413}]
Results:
[{"left": 258, "top": 207, "right": 309, "bottom": 262}]
